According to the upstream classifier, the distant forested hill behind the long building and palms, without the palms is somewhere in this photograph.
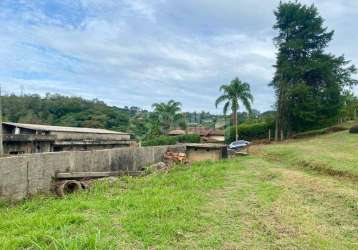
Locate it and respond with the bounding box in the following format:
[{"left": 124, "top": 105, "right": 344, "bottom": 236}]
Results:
[{"left": 2, "top": 94, "right": 274, "bottom": 138}]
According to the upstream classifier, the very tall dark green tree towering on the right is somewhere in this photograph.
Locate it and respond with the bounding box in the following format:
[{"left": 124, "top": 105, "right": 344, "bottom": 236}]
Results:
[{"left": 271, "top": 1, "right": 357, "bottom": 138}]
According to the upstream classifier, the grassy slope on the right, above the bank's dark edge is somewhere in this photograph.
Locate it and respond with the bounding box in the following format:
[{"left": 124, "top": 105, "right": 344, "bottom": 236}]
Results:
[{"left": 260, "top": 131, "right": 358, "bottom": 180}]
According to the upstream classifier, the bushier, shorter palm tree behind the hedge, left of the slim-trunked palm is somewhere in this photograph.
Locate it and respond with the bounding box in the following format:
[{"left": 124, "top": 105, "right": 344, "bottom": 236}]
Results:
[{"left": 152, "top": 100, "right": 182, "bottom": 134}]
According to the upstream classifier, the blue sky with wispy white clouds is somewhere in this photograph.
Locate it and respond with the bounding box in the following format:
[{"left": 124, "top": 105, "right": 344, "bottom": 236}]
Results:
[{"left": 0, "top": 0, "right": 358, "bottom": 113}]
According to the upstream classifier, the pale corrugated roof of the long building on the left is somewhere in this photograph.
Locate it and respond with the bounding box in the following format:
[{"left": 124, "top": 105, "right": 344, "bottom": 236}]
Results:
[{"left": 3, "top": 122, "right": 128, "bottom": 135}]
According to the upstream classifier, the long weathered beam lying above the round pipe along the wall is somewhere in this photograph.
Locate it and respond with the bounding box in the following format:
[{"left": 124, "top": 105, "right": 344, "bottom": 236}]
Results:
[{"left": 56, "top": 171, "right": 142, "bottom": 179}]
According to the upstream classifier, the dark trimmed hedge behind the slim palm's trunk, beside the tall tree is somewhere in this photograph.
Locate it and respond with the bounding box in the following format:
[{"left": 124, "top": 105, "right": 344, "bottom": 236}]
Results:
[{"left": 225, "top": 122, "right": 274, "bottom": 143}]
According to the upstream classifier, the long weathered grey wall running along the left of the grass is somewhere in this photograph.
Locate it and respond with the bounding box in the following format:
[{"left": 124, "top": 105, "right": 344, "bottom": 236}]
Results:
[{"left": 0, "top": 145, "right": 186, "bottom": 200}]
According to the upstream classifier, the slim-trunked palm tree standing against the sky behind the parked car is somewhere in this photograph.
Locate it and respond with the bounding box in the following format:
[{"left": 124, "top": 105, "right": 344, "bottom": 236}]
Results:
[{"left": 215, "top": 78, "right": 254, "bottom": 141}]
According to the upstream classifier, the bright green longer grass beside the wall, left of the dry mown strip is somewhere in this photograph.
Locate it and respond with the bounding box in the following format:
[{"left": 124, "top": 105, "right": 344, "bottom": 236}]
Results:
[{"left": 0, "top": 162, "right": 241, "bottom": 249}]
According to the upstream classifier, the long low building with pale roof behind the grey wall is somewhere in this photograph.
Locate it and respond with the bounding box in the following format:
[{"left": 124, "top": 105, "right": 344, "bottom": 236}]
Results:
[{"left": 2, "top": 122, "right": 135, "bottom": 155}]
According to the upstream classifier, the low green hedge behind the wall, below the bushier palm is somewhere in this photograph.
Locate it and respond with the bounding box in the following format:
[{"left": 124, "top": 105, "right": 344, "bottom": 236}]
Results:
[{"left": 142, "top": 134, "right": 200, "bottom": 146}]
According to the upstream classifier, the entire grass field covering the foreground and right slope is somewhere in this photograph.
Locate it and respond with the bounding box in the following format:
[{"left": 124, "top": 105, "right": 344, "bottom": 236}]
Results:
[{"left": 0, "top": 132, "right": 358, "bottom": 249}]
